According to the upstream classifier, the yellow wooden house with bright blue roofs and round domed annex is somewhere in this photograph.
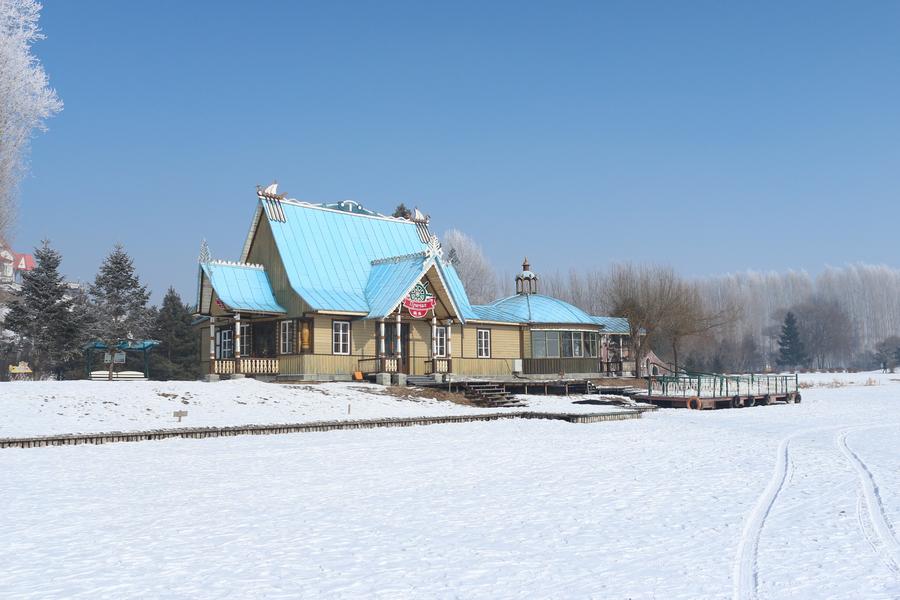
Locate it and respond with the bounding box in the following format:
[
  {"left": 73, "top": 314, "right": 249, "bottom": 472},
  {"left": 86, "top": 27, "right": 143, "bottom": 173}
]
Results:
[{"left": 198, "top": 185, "right": 633, "bottom": 380}]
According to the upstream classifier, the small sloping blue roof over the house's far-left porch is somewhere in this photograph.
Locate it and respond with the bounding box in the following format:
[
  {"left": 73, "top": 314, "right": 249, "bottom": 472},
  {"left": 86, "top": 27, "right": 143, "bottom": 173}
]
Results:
[{"left": 200, "top": 262, "right": 286, "bottom": 313}]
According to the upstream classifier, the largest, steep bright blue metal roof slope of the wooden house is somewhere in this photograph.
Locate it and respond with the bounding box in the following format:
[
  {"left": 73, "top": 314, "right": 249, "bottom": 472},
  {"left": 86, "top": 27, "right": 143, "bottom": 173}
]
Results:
[{"left": 269, "top": 201, "right": 427, "bottom": 313}]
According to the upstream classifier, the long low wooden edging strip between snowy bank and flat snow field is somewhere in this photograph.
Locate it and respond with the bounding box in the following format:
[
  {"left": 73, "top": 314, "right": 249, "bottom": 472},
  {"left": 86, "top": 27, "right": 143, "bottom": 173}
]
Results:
[{"left": 0, "top": 410, "right": 642, "bottom": 448}]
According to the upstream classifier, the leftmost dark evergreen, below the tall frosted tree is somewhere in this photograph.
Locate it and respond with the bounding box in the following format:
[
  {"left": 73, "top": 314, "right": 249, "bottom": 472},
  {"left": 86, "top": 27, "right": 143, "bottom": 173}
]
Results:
[{"left": 5, "top": 240, "right": 86, "bottom": 376}]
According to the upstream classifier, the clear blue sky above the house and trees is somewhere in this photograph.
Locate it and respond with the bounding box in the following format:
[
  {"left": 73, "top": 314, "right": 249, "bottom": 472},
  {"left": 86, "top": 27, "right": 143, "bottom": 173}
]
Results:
[{"left": 14, "top": 0, "right": 900, "bottom": 301}]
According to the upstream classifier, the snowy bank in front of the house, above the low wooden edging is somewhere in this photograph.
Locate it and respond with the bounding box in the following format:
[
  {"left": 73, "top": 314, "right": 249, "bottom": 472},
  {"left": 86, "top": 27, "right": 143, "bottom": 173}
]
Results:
[{"left": 0, "top": 379, "right": 617, "bottom": 437}]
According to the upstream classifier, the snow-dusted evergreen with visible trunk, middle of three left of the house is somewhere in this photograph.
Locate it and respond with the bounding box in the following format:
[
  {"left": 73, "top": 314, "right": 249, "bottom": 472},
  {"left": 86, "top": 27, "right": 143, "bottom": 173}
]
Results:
[{"left": 91, "top": 244, "right": 151, "bottom": 379}]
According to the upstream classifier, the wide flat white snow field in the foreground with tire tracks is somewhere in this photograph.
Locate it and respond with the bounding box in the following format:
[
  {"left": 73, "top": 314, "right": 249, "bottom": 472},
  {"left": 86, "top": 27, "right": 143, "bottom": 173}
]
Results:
[{"left": 0, "top": 374, "right": 900, "bottom": 599}]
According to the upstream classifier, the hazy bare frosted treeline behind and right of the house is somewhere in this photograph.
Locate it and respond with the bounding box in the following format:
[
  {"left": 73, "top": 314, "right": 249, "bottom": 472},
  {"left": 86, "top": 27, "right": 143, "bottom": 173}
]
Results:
[{"left": 444, "top": 231, "right": 900, "bottom": 372}]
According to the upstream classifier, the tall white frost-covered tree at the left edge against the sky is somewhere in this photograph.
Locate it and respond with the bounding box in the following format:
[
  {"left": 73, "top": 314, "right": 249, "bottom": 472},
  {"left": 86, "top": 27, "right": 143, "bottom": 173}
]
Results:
[{"left": 0, "top": 0, "right": 62, "bottom": 235}]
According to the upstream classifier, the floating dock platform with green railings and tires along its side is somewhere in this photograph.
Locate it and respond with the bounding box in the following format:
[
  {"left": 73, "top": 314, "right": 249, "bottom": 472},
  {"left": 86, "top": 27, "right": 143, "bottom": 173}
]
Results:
[{"left": 634, "top": 373, "right": 801, "bottom": 410}]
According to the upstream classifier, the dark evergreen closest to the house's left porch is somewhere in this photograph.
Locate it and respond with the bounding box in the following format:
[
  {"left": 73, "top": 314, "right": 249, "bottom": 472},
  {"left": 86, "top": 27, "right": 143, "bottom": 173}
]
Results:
[{"left": 150, "top": 288, "right": 200, "bottom": 379}]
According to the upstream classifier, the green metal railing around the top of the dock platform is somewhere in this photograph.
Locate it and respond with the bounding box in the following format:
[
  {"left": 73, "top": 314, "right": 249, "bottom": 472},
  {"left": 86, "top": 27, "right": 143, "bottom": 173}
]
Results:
[{"left": 647, "top": 373, "right": 799, "bottom": 398}]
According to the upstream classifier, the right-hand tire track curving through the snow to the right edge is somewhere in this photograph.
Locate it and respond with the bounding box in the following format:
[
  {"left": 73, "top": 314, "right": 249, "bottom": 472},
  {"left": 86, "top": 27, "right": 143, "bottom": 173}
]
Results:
[{"left": 835, "top": 424, "right": 900, "bottom": 573}]
